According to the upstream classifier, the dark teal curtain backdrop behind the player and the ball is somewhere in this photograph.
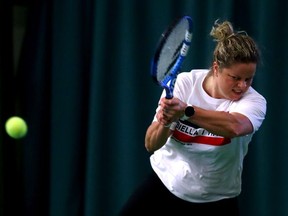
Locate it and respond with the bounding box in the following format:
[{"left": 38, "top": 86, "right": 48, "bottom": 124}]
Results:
[{"left": 0, "top": 0, "right": 288, "bottom": 216}]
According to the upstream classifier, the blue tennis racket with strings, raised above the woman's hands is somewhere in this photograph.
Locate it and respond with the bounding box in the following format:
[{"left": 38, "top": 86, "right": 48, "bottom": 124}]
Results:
[{"left": 151, "top": 16, "right": 193, "bottom": 99}]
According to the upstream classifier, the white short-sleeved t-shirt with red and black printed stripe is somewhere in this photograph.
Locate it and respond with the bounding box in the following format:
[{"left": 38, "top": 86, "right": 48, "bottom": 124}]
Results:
[{"left": 150, "top": 70, "right": 266, "bottom": 203}]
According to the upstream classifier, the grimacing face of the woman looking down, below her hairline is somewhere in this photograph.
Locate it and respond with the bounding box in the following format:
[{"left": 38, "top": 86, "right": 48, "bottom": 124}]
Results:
[{"left": 213, "top": 63, "right": 256, "bottom": 100}]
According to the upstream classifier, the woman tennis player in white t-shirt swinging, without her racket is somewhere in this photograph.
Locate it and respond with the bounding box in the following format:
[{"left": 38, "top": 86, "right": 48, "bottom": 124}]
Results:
[{"left": 120, "top": 21, "right": 266, "bottom": 216}]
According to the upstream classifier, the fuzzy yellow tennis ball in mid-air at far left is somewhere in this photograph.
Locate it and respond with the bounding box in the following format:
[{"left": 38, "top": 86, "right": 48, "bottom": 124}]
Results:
[{"left": 5, "top": 116, "right": 28, "bottom": 139}]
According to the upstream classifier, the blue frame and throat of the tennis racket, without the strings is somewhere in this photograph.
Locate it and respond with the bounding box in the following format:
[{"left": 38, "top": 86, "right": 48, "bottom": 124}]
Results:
[{"left": 151, "top": 16, "right": 193, "bottom": 99}]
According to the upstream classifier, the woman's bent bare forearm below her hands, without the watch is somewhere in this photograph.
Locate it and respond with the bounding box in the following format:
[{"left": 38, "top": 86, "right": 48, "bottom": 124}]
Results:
[{"left": 145, "top": 122, "right": 171, "bottom": 152}]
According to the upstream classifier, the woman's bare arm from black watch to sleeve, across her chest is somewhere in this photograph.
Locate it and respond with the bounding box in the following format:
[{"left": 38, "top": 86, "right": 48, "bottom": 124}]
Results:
[{"left": 189, "top": 107, "right": 253, "bottom": 138}]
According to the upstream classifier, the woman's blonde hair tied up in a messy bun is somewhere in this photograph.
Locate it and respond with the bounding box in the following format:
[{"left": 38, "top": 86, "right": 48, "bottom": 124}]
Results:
[{"left": 210, "top": 20, "right": 260, "bottom": 68}]
